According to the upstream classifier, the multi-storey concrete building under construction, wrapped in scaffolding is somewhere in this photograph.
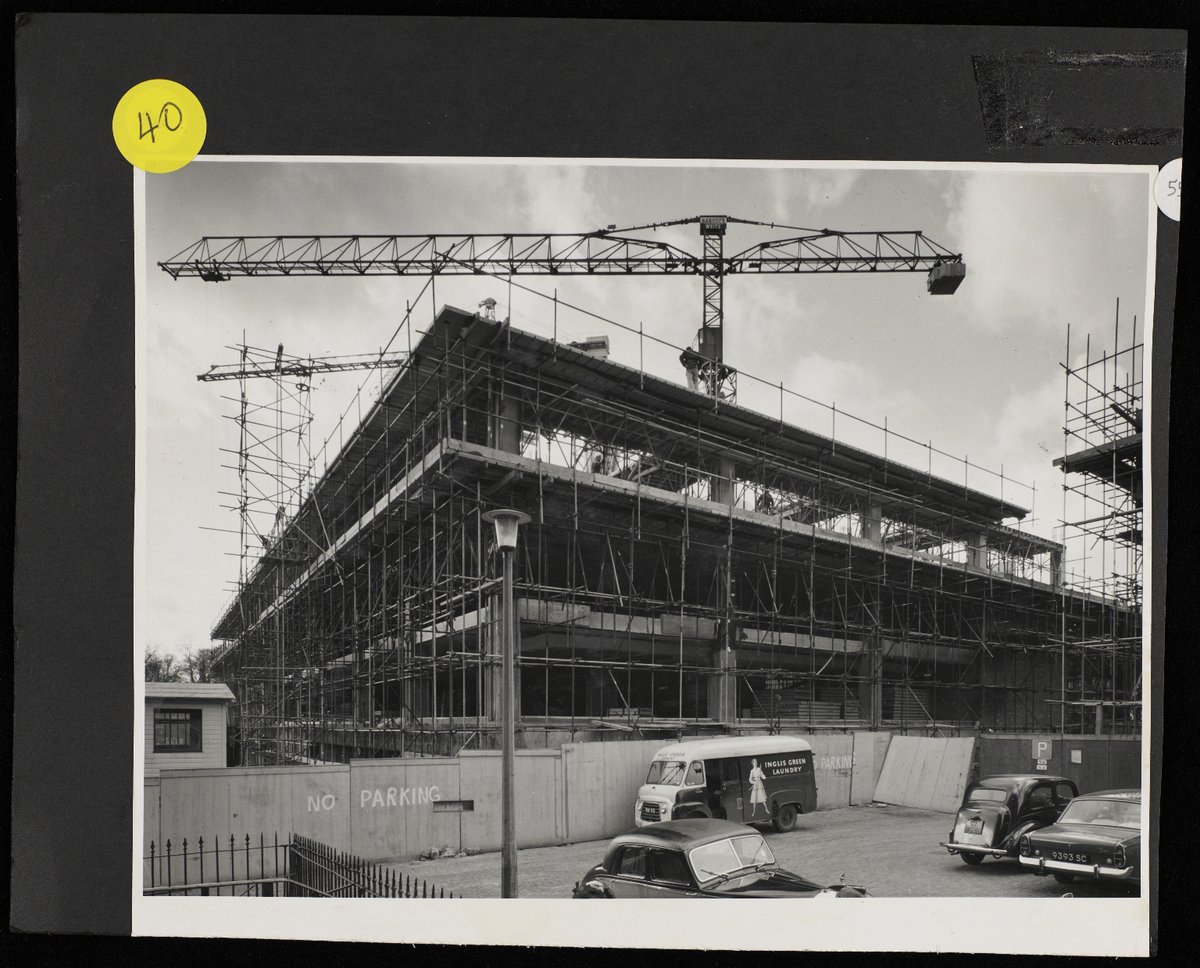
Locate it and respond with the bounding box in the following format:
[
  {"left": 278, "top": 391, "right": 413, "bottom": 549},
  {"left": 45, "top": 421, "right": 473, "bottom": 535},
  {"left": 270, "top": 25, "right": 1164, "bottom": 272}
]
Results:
[{"left": 212, "top": 307, "right": 1140, "bottom": 764}]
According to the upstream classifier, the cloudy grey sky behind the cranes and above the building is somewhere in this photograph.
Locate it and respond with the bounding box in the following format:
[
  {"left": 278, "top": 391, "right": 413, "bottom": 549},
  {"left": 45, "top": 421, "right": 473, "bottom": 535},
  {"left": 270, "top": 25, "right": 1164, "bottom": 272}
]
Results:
[{"left": 137, "top": 158, "right": 1152, "bottom": 650}]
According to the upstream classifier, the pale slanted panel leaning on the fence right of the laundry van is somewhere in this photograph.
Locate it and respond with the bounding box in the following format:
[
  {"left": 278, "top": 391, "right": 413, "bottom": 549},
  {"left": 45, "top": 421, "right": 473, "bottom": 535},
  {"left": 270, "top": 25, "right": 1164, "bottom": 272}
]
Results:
[{"left": 875, "top": 736, "right": 974, "bottom": 813}]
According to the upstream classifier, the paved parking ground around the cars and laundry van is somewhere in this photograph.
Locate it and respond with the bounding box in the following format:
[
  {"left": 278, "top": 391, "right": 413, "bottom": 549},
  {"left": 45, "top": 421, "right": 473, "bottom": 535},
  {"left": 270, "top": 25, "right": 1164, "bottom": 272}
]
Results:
[{"left": 397, "top": 806, "right": 1142, "bottom": 897}]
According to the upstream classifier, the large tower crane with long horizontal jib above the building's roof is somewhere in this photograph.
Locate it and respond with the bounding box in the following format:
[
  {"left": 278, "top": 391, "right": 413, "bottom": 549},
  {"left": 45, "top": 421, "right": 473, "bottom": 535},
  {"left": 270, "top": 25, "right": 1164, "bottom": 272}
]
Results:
[{"left": 158, "top": 215, "right": 966, "bottom": 401}]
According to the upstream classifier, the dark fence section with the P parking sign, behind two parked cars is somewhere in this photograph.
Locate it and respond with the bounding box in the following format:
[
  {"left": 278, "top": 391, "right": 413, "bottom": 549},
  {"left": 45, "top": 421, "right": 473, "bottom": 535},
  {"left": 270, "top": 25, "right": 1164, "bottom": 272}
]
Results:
[{"left": 979, "top": 733, "right": 1141, "bottom": 793}]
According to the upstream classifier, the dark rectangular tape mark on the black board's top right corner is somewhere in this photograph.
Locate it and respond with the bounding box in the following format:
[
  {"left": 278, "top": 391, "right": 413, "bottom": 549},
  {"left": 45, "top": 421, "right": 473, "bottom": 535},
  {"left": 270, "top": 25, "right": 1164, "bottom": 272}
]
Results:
[{"left": 972, "top": 50, "right": 1187, "bottom": 150}]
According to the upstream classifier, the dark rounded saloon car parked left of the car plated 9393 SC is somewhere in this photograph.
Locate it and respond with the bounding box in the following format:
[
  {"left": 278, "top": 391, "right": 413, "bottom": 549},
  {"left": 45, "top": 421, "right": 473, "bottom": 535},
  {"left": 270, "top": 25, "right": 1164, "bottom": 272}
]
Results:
[{"left": 942, "top": 774, "right": 1079, "bottom": 865}]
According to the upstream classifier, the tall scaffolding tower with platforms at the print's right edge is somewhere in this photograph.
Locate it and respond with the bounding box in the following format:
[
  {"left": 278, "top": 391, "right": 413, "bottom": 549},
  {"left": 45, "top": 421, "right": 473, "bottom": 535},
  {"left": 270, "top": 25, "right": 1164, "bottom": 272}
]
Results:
[{"left": 1054, "top": 302, "right": 1144, "bottom": 734}]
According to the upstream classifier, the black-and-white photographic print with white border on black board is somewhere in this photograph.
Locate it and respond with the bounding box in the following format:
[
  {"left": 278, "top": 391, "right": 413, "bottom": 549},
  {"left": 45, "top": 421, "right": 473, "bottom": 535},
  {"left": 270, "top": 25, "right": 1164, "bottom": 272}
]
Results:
[{"left": 136, "top": 157, "right": 1157, "bottom": 952}]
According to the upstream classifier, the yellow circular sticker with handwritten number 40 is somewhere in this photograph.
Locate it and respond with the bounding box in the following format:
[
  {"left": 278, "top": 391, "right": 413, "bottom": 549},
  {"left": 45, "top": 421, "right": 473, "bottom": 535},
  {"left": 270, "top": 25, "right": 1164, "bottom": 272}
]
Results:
[{"left": 113, "top": 79, "right": 208, "bottom": 173}]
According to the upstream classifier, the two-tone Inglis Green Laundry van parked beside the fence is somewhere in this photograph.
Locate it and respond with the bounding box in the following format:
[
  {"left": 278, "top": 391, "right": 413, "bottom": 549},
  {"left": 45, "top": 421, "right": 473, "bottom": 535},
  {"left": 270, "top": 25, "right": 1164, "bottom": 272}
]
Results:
[{"left": 634, "top": 736, "right": 817, "bottom": 831}]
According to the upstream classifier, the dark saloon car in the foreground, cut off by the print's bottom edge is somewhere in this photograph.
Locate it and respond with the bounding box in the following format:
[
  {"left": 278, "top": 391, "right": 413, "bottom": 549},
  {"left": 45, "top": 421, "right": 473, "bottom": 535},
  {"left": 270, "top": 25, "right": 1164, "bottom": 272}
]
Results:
[{"left": 571, "top": 818, "right": 866, "bottom": 897}]
